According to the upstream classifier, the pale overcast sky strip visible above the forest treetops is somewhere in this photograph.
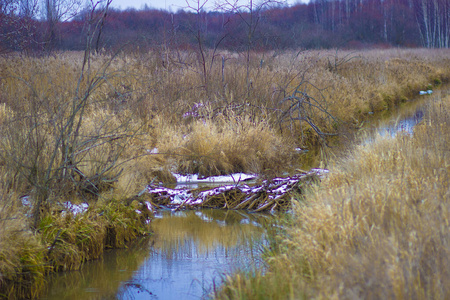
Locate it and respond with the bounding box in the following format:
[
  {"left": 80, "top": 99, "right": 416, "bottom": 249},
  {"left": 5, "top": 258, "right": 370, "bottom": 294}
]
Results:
[{"left": 112, "top": 0, "right": 308, "bottom": 12}]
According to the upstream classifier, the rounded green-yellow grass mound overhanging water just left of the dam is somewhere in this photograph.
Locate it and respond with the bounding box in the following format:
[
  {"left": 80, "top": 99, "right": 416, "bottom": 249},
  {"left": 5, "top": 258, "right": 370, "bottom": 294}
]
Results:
[{"left": 39, "top": 201, "right": 150, "bottom": 271}]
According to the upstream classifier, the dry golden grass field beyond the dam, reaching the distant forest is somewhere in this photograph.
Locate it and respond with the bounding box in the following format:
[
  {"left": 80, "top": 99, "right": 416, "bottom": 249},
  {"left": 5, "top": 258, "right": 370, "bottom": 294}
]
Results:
[{"left": 0, "top": 49, "right": 450, "bottom": 193}]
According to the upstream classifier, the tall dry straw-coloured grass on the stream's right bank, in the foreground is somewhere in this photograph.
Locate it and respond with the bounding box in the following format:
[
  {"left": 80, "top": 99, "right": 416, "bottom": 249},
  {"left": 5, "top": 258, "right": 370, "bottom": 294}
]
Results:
[{"left": 216, "top": 89, "right": 450, "bottom": 299}]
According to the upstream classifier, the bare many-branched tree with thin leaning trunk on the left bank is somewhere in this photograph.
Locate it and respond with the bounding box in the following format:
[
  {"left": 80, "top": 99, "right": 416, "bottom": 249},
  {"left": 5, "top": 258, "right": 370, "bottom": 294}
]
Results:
[{"left": 0, "top": 0, "right": 135, "bottom": 228}]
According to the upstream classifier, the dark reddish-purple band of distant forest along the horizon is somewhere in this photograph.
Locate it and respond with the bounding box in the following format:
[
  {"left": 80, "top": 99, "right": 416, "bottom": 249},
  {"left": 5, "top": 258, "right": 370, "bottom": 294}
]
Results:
[{"left": 0, "top": 0, "right": 450, "bottom": 53}]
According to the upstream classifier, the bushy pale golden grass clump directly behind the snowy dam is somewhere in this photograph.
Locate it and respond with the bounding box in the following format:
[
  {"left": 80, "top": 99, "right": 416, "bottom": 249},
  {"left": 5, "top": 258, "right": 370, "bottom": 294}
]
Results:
[{"left": 156, "top": 111, "right": 294, "bottom": 176}]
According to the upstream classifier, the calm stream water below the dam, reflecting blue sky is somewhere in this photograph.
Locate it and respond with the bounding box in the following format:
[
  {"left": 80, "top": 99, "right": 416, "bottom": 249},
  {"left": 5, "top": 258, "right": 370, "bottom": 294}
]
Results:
[{"left": 43, "top": 210, "right": 271, "bottom": 300}]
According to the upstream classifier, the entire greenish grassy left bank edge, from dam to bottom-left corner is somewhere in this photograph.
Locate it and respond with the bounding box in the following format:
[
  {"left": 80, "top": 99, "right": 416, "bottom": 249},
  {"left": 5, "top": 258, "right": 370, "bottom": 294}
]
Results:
[{"left": 0, "top": 200, "right": 152, "bottom": 299}]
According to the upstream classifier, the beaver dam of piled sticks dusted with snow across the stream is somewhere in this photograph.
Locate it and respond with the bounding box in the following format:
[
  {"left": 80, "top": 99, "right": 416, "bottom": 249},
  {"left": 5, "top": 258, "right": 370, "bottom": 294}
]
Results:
[{"left": 141, "top": 169, "right": 328, "bottom": 212}]
